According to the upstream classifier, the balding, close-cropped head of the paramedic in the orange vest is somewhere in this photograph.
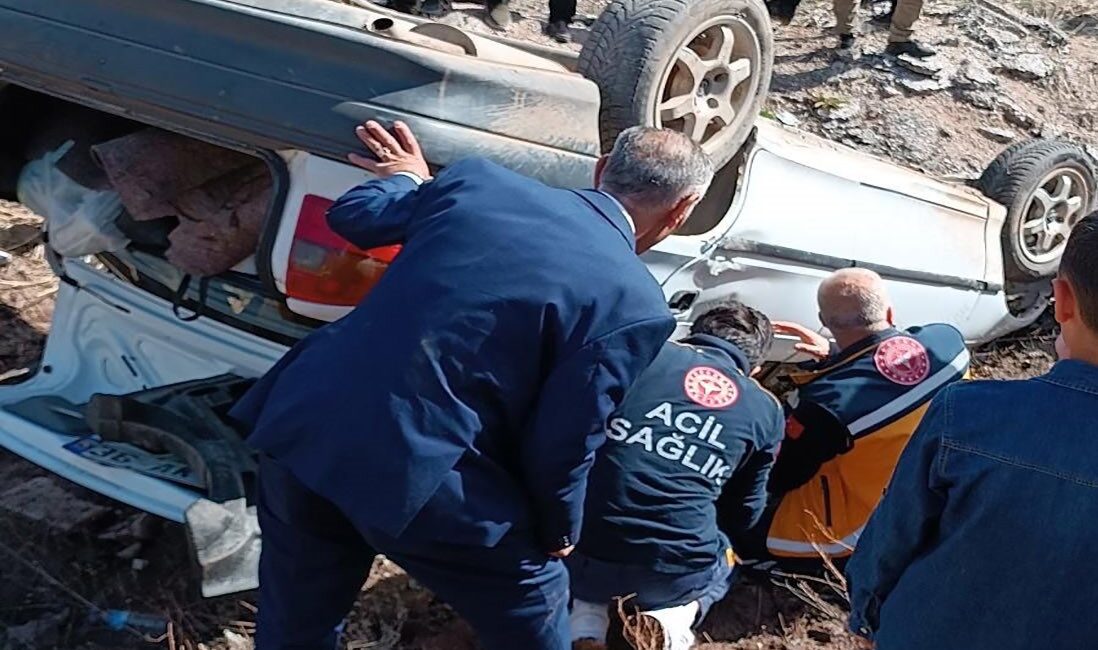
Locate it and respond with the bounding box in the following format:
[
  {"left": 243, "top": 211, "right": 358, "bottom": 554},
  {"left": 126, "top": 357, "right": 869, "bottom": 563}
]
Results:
[{"left": 818, "top": 268, "right": 890, "bottom": 330}]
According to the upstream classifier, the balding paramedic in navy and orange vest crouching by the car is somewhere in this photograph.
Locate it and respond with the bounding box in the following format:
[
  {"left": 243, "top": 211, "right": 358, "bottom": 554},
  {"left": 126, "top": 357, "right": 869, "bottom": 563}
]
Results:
[{"left": 746, "top": 268, "right": 970, "bottom": 561}]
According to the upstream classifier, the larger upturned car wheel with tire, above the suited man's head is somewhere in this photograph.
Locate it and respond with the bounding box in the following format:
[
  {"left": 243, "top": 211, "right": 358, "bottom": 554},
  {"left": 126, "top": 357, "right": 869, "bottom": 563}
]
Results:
[{"left": 578, "top": 0, "right": 774, "bottom": 168}]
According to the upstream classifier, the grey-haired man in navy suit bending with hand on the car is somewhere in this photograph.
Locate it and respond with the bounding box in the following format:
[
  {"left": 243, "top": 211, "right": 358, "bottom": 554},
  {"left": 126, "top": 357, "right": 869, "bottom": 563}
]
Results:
[{"left": 233, "top": 122, "right": 713, "bottom": 650}]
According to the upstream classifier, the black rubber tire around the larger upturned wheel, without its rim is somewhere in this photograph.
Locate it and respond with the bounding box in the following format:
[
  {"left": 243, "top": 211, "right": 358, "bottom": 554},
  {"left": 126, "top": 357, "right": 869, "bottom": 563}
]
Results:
[{"left": 578, "top": 0, "right": 774, "bottom": 168}]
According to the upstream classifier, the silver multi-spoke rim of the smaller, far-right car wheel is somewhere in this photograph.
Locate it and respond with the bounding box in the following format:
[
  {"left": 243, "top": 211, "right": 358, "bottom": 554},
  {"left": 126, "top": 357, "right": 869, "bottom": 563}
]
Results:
[{"left": 1018, "top": 169, "right": 1090, "bottom": 265}]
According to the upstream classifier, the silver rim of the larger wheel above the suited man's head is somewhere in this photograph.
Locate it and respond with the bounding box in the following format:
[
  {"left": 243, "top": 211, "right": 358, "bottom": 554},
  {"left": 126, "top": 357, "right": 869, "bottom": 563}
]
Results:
[{"left": 654, "top": 15, "right": 762, "bottom": 153}]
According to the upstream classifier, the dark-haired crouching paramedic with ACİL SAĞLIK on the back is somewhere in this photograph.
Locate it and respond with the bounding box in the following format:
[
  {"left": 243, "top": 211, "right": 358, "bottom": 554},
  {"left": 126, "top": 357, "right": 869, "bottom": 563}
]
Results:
[{"left": 568, "top": 303, "right": 784, "bottom": 649}]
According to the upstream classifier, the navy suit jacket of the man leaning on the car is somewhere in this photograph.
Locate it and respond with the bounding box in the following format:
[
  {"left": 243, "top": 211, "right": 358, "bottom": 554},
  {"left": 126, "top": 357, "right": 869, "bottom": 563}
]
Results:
[{"left": 233, "top": 159, "right": 674, "bottom": 548}]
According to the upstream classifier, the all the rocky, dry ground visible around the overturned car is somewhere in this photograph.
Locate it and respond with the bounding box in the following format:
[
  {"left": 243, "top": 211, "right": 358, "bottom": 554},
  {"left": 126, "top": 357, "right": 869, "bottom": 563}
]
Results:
[{"left": 0, "top": 0, "right": 1080, "bottom": 650}]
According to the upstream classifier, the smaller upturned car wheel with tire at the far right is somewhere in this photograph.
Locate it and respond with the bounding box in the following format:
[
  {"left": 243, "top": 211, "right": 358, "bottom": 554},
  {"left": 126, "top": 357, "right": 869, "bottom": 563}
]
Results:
[{"left": 976, "top": 139, "right": 1096, "bottom": 282}]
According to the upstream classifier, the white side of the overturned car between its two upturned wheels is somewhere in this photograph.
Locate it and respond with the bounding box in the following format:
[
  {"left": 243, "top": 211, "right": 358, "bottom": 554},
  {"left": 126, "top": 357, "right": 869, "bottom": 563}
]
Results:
[{"left": 664, "top": 119, "right": 999, "bottom": 358}]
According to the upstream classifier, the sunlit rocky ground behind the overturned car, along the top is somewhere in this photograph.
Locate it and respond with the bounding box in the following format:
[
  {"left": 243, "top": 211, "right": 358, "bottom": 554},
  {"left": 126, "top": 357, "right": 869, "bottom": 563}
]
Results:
[{"left": 432, "top": 0, "right": 1098, "bottom": 179}]
